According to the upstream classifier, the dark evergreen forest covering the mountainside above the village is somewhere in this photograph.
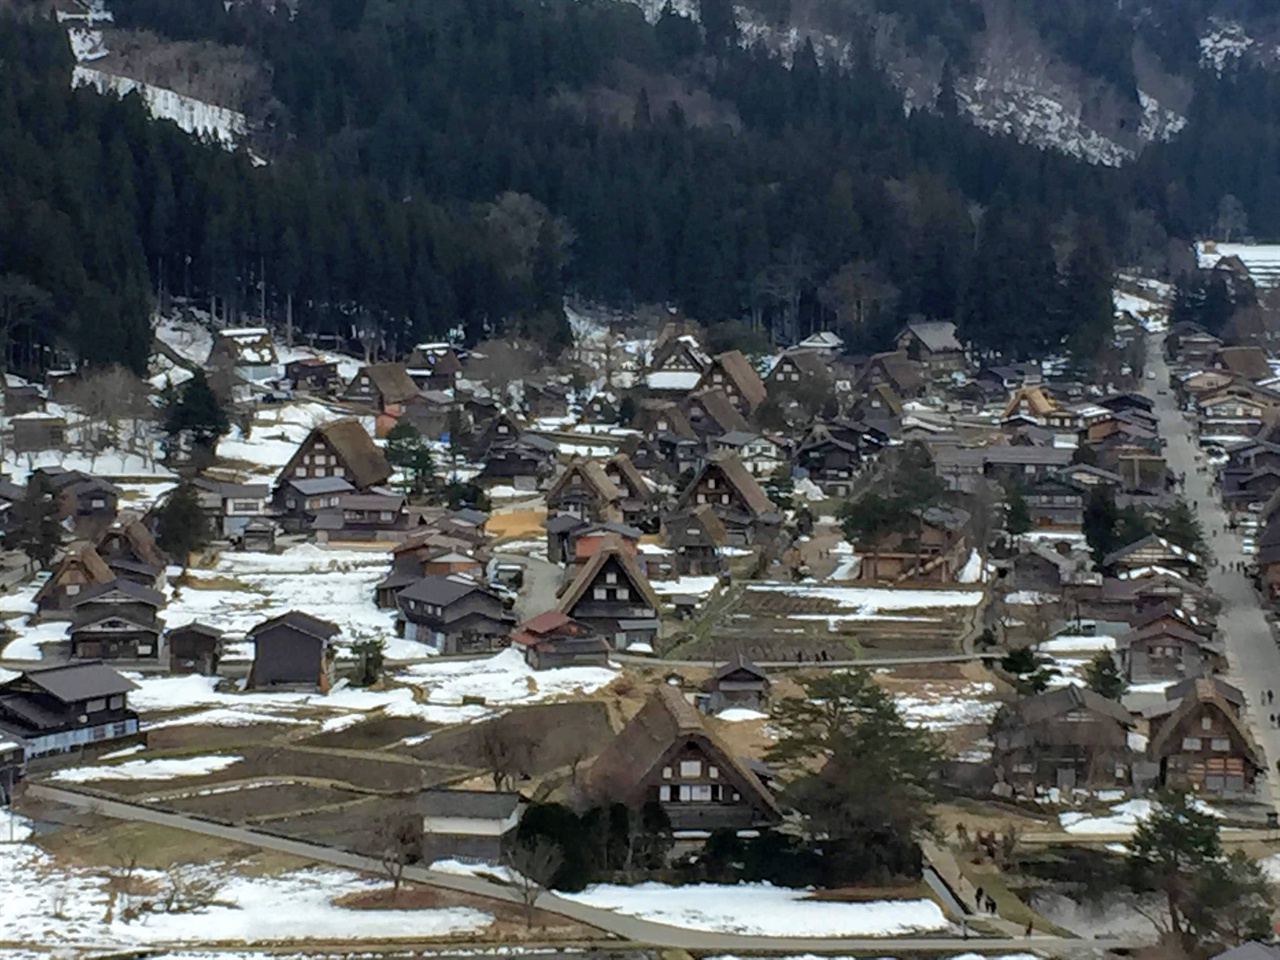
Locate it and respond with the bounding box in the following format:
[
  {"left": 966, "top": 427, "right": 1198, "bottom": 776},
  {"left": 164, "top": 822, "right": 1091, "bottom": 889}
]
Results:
[{"left": 0, "top": 0, "right": 1280, "bottom": 378}]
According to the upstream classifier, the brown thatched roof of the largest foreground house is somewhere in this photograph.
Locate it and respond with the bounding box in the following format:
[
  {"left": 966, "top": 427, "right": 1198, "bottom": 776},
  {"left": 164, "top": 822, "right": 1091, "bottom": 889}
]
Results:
[{"left": 585, "top": 684, "right": 782, "bottom": 819}]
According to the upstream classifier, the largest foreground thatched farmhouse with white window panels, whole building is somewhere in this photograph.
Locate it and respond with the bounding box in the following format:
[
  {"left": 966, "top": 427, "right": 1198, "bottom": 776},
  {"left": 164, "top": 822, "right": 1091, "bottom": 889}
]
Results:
[{"left": 584, "top": 684, "right": 782, "bottom": 831}]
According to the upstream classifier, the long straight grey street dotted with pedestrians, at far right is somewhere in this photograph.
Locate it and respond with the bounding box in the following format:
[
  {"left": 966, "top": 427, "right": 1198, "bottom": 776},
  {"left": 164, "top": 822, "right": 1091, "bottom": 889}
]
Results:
[{"left": 1144, "top": 337, "right": 1280, "bottom": 809}]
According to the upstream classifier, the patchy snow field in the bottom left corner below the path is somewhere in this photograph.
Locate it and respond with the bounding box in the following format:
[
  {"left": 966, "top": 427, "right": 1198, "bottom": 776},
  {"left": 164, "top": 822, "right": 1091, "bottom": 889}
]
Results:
[{"left": 0, "top": 810, "right": 493, "bottom": 952}]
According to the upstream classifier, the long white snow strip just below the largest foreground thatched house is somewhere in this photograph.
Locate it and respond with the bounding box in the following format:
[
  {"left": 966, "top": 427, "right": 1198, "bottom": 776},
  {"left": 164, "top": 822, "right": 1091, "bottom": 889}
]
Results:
[{"left": 561, "top": 883, "right": 950, "bottom": 937}]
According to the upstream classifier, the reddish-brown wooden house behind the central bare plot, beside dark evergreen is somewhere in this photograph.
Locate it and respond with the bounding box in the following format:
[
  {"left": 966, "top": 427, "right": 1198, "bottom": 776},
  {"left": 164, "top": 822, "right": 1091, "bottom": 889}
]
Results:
[{"left": 858, "top": 507, "right": 969, "bottom": 585}]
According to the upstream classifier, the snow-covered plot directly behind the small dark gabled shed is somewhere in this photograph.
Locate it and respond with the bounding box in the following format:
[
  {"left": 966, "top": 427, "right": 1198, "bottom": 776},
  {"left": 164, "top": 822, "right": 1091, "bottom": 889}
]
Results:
[{"left": 164, "top": 544, "right": 392, "bottom": 657}]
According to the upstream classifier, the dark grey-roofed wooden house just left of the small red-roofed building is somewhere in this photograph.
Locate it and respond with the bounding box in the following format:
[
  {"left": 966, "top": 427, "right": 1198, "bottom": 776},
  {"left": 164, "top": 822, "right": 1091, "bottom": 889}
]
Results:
[{"left": 396, "top": 573, "right": 516, "bottom": 654}]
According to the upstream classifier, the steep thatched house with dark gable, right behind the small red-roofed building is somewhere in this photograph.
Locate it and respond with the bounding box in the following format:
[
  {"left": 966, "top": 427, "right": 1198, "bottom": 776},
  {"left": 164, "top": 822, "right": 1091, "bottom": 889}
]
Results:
[{"left": 557, "top": 534, "right": 662, "bottom": 650}]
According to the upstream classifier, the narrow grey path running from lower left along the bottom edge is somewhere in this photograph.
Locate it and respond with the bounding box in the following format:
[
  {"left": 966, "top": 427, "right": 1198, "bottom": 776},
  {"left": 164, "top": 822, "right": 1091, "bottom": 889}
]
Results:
[{"left": 27, "top": 783, "right": 1138, "bottom": 957}]
